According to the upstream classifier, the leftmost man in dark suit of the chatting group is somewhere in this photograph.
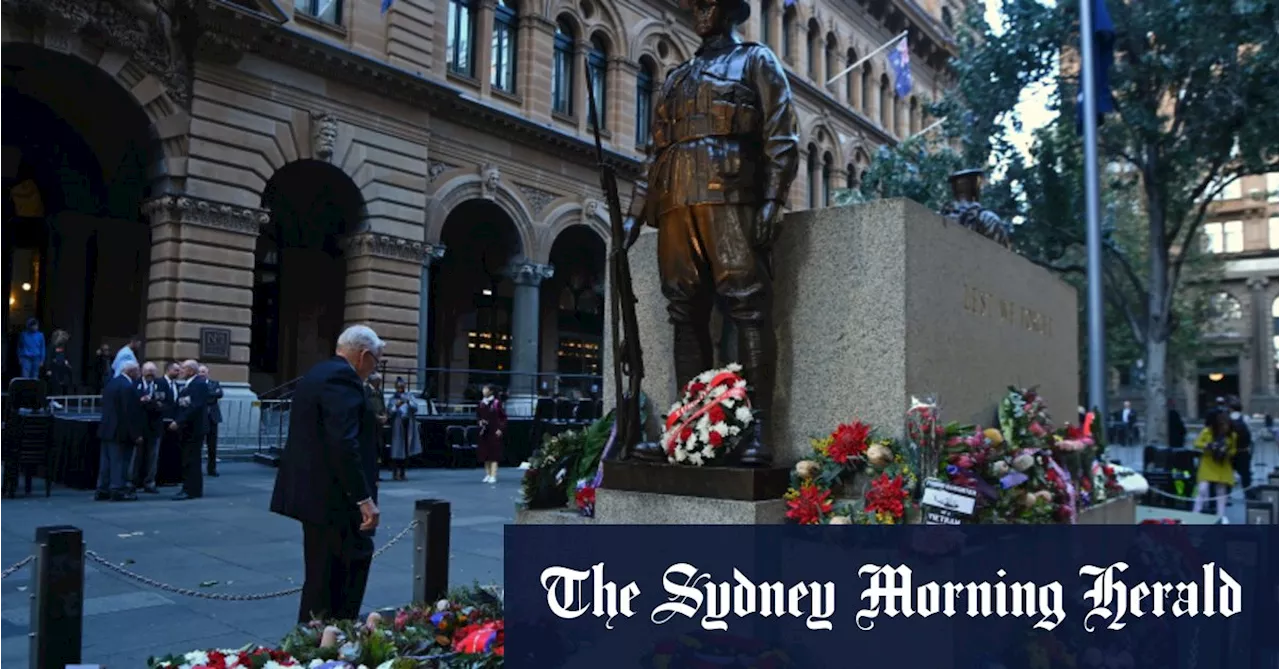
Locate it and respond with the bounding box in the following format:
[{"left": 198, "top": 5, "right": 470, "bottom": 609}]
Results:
[{"left": 95, "top": 362, "right": 147, "bottom": 501}]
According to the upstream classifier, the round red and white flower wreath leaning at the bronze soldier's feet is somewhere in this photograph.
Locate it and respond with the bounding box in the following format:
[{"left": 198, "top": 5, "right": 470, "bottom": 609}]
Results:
[{"left": 662, "top": 365, "right": 755, "bottom": 467}]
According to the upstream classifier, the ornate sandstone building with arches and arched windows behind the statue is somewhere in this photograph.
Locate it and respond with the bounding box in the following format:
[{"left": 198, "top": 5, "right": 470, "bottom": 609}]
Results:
[{"left": 0, "top": 0, "right": 964, "bottom": 414}]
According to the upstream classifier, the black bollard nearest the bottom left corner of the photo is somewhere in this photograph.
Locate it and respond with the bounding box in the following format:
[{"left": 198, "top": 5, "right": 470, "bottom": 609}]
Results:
[{"left": 31, "top": 524, "right": 84, "bottom": 669}]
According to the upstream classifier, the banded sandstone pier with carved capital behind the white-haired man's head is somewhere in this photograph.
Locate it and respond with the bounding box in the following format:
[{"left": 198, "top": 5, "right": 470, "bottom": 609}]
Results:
[{"left": 342, "top": 232, "right": 436, "bottom": 377}]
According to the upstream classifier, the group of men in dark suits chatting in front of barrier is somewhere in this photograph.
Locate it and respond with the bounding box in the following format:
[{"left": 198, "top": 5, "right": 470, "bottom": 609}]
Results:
[{"left": 95, "top": 338, "right": 223, "bottom": 501}]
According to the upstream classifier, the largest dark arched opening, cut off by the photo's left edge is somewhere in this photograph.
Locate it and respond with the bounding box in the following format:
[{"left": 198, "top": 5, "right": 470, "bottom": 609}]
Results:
[{"left": 0, "top": 45, "right": 163, "bottom": 393}]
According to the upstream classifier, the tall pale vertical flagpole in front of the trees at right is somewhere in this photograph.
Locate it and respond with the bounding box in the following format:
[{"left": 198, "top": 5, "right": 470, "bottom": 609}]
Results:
[{"left": 1080, "top": 0, "right": 1111, "bottom": 425}]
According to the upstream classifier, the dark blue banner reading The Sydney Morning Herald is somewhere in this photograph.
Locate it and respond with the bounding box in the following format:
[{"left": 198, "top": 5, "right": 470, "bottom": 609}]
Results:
[{"left": 506, "top": 526, "right": 1280, "bottom": 669}]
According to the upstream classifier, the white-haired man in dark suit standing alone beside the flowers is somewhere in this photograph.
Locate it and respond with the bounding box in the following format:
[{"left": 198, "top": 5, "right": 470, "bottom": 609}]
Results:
[{"left": 271, "top": 325, "right": 385, "bottom": 623}]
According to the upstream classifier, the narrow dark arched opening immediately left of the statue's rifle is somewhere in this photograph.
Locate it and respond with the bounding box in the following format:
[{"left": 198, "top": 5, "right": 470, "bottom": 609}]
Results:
[{"left": 541, "top": 225, "right": 608, "bottom": 398}]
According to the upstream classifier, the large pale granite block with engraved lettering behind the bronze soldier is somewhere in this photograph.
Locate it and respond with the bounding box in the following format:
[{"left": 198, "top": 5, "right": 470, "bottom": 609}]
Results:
[{"left": 602, "top": 200, "right": 1079, "bottom": 470}]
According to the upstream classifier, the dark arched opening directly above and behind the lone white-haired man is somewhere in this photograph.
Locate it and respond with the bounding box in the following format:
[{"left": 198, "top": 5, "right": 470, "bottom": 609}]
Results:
[{"left": 250, "top": 160, "right": 365, "bottom": 395}]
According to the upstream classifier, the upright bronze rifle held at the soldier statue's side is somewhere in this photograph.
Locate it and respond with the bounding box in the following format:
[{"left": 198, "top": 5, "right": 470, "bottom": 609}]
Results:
[{"left": 584, "top": 59, "right": 644, "bottom": 459}]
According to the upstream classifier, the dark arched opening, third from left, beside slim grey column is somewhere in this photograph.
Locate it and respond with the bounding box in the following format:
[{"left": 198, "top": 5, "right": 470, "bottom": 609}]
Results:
[{"left": 428, "top": 200, "right": 524, "bottom": 405}]
